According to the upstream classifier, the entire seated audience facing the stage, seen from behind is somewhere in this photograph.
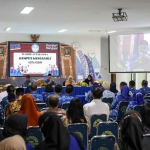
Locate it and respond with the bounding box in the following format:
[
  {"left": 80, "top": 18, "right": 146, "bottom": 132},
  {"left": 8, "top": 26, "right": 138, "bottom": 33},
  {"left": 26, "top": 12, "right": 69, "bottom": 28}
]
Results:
[{"left": 0, "top": 77, "right": 150, "bottom": 150}]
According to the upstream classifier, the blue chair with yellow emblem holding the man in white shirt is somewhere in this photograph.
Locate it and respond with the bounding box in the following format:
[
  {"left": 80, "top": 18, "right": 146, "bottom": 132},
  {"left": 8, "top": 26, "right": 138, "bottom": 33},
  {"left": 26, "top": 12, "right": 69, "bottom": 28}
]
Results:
[{"left": 89, "top": 114, "right": 107, "bottom": 138}]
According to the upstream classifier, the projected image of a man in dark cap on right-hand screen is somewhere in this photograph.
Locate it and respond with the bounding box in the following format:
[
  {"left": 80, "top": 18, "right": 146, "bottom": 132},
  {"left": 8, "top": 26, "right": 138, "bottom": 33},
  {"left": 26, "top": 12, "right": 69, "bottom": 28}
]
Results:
[{"left": 109, "top": 34, "right": 150, "bottom": 72}]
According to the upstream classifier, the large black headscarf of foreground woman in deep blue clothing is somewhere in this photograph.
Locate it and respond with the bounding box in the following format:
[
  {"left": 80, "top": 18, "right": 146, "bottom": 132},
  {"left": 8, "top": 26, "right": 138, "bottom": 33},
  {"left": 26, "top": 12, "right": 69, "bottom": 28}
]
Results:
[{"left": 37, "top": 112, "right": 70, "bottom": 150}]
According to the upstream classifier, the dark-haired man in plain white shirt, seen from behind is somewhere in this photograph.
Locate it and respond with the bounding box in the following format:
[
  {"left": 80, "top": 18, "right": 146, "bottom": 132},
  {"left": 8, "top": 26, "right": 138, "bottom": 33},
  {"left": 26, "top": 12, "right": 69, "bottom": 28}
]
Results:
[{"left": 83, "top": 88, "right": 109, "bottom": 120}]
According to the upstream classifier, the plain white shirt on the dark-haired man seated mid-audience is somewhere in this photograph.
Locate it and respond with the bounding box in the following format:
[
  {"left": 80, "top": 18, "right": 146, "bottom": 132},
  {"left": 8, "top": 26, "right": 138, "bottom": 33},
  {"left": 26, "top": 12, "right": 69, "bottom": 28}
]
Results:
[{"left": 83, "top": 99, "right": 109, "bottom": 120}]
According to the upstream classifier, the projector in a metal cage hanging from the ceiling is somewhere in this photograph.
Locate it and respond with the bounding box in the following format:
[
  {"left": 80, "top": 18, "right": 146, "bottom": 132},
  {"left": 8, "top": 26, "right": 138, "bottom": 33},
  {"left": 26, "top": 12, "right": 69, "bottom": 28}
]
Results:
[{"left": 112, "top": 9, "right": 128, "bottom": 22}]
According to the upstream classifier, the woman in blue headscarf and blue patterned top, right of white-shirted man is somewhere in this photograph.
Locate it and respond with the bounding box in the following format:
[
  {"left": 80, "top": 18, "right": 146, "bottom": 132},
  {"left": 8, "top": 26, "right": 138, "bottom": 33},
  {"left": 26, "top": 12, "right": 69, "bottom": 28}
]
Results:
[{"left": 110, "top": 85, "right": 132, "bottom": 116}]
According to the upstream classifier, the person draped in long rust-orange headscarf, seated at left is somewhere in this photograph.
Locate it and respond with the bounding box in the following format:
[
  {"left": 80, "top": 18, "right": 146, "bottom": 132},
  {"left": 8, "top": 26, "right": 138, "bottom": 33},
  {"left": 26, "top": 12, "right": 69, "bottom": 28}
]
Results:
[{"left": 17, "top": 94, "right": 42, "bottom": 126}]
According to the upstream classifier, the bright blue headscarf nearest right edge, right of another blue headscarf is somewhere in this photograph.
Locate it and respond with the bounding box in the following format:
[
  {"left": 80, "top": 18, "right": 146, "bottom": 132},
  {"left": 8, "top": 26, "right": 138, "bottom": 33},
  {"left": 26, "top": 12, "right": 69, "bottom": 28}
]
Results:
[{"left": 132, "top": 90, "right": 145, "bottom": 105}]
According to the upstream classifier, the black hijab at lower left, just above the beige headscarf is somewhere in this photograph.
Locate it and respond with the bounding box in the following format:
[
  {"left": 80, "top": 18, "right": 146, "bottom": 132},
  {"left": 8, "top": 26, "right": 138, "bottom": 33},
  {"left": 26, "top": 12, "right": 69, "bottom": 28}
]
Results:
[{"left": 3, "top": 114, "right": 28, "bottom": 138}]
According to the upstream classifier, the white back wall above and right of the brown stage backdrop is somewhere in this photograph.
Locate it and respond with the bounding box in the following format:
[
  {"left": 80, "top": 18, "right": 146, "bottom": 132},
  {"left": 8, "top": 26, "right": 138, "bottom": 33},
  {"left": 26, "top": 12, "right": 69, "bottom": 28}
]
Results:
[{"left": 0, "top": 34, "right": 101, "bottom": 85}]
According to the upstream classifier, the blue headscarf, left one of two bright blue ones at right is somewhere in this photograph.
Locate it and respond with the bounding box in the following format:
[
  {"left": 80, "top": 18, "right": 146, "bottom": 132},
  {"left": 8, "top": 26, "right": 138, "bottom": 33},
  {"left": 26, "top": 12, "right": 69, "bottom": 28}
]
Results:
[{"left": 118, "top": 85, "right": 132, "bottom": 102}]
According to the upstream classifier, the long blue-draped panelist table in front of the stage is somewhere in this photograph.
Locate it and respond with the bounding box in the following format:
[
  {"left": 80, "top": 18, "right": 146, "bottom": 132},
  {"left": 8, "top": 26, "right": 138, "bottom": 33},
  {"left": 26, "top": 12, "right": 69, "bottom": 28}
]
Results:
[{"left": 24, "top": 86, "right": 92, "bottom": 97}]
